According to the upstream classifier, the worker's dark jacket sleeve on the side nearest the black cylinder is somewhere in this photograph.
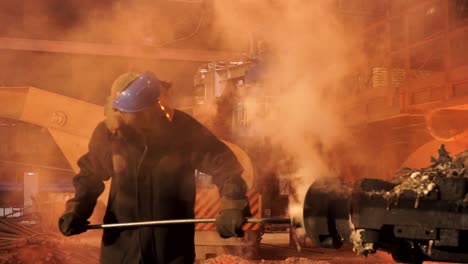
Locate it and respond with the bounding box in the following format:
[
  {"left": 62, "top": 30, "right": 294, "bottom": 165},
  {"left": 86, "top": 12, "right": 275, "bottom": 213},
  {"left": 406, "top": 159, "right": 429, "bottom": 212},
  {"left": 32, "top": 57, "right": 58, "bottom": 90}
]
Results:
[{"left": 191, "top": 121, "right": 247, "bottom": 202}]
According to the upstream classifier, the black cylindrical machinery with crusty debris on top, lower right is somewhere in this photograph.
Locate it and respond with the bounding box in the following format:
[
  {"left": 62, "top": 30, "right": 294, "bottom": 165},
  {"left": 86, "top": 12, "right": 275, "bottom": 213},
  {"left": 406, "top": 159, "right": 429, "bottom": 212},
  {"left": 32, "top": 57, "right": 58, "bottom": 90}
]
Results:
[{"left": 304, "top": 146, "right": 468, "bottom": 263}]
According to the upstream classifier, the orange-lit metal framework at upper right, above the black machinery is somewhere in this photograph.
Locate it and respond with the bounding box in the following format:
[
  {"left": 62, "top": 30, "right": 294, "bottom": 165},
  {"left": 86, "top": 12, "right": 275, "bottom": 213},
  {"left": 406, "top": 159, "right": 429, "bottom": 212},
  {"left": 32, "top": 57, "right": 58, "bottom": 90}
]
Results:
[{"left": 354, "top": 0, "right": 468, "bottom": 119}]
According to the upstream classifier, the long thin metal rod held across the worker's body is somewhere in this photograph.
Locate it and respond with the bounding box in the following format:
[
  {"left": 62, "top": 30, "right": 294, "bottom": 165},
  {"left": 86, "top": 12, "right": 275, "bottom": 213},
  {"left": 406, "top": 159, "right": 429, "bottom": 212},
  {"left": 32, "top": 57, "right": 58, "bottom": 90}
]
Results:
[{"left": 87, "top": 218, "right": 292, "bottom": 229}]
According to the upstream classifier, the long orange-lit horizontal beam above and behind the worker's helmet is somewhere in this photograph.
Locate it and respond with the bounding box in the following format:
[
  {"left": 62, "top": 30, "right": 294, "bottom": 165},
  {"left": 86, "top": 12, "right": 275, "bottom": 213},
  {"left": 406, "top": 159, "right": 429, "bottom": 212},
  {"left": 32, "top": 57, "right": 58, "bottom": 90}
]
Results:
[{"left": 0, "top": 38, "right": 246, "bottom": 62}]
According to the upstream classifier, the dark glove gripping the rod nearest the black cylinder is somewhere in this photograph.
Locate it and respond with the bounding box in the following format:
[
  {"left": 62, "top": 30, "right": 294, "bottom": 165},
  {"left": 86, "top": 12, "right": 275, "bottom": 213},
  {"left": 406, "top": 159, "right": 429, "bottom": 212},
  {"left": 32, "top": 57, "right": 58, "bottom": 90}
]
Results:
[{"left": 216, "top": 198, "right": 250, "bottom": 238}]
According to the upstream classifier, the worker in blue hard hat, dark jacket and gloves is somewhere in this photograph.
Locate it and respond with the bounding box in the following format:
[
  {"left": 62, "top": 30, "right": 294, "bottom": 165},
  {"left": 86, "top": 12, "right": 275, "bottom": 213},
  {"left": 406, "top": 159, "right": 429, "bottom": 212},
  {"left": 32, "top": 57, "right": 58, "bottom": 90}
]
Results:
[{"left": 59, "top": 72, "right": 250, "bottom": 264}]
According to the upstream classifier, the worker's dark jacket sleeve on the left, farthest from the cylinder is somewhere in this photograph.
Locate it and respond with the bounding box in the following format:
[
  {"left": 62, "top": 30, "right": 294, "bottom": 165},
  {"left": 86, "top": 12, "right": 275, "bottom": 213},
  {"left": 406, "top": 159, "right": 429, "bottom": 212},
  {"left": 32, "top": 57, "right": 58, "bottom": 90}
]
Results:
[{"left": 65, "top": 123, "right": 112, "bottom": 219}]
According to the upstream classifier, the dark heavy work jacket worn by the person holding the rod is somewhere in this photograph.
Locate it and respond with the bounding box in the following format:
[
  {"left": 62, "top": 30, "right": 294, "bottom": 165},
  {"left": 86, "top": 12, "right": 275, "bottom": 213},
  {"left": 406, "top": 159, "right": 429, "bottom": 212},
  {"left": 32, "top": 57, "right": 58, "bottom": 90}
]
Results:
[{"left": 66, "top": 111, "right": 250, "bottom": 264}]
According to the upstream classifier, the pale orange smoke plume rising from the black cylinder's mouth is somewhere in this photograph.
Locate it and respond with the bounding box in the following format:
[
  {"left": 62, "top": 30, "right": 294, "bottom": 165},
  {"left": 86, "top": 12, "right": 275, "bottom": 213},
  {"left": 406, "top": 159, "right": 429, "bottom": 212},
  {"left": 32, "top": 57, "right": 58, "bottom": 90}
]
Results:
[{"left": 211, "top": 0, "right": 359, "bottom": 224}]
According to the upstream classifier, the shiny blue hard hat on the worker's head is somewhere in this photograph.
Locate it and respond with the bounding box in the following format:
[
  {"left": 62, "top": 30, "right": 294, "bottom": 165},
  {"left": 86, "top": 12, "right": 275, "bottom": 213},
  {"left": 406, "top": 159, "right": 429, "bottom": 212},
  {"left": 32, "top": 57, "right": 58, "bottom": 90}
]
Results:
[{"left": 112, "top": 71, "right": 161, "bottom": 112}]
